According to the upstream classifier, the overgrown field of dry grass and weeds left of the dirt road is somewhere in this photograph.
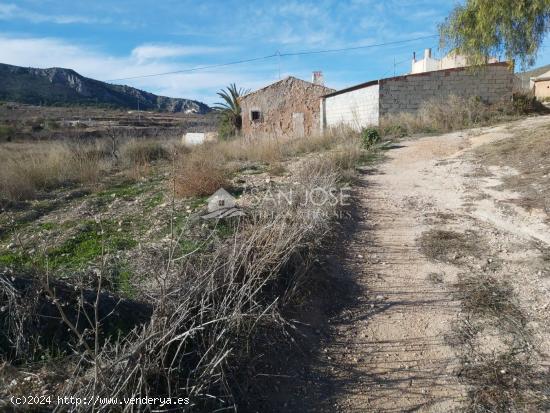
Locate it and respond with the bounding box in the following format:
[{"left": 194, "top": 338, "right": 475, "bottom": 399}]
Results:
[{"left": 0, "top": 107, "right": 368, "bottom": 411}]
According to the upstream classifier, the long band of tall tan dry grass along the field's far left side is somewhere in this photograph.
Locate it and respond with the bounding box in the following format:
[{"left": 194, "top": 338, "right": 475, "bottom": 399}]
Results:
[{"left": 0, "top": 139, "right": 184, "bottom": 200}]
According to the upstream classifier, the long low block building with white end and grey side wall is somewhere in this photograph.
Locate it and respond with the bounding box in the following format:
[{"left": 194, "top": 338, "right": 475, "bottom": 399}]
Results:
[{"left": 320, "top": 62, "right": 514, "bottom": 130}]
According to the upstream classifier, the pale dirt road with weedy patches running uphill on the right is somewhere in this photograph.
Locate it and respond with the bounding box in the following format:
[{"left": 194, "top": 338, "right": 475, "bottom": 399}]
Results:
[{"left": 322, "top": 117, "right": 550, "bottom": 412}]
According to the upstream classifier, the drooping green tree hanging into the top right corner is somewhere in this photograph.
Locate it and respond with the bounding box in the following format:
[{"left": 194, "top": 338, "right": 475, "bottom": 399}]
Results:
[{"left": 439, "top": 0, "right": 550, "bottom": 68}]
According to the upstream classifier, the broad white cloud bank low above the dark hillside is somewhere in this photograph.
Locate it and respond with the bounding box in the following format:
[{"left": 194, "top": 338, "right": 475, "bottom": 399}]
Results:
[{"left": 0, "top": 34, "right": 276, "bottom": 104}]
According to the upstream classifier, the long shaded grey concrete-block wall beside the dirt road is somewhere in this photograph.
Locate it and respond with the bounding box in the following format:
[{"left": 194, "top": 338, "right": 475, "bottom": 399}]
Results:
[{"left": 379, "top": 63, "right": 514, "bottom": 116}]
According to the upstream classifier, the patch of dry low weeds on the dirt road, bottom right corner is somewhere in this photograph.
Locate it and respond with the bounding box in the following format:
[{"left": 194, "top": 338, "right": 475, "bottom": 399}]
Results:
[{"left": 454, "top": 273, "right": 550, "bottom": 413}]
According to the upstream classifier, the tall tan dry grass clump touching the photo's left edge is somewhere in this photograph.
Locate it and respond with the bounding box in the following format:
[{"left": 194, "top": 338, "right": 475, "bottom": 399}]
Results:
[{"left": 0, "top": 142, "right": 110, "bottom": 200}]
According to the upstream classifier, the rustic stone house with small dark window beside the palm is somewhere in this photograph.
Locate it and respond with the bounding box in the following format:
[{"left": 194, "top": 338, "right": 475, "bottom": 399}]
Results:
[{"left": 240, "top": 73, "right": 334, "bottom": 137}]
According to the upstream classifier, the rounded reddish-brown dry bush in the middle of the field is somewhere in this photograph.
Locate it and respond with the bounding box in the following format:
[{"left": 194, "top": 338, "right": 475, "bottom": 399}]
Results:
[{"left": 175, "top": 146, "right": 230, "bottom": 197}]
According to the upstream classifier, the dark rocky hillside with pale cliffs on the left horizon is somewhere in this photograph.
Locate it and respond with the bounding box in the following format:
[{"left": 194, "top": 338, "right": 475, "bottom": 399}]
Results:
[{"left": 0, "top": 63, "right": 210, "bottom": 113}]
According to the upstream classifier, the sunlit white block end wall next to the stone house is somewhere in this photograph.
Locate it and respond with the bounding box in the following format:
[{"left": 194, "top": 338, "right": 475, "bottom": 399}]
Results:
[{"left": 321, "top": 84, "right": 379, "bottom": 130}]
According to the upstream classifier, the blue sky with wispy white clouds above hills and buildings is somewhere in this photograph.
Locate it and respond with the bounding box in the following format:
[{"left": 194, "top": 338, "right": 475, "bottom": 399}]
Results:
[{"left": 0, "top": 0, "right": 550, "bottom": 104}]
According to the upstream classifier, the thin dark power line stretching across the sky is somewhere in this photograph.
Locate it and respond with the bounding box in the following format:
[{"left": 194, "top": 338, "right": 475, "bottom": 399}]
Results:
[{"left": 106, "top": 34, "right": 438, "bottom": 82}]
